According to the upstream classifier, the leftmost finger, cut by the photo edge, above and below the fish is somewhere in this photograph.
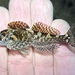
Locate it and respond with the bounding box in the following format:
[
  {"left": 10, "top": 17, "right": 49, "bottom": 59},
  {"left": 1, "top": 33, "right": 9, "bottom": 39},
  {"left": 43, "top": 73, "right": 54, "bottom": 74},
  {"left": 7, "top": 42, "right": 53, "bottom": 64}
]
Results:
[{"left": 0, "top": 7, "right": 9, "bottom": 75}]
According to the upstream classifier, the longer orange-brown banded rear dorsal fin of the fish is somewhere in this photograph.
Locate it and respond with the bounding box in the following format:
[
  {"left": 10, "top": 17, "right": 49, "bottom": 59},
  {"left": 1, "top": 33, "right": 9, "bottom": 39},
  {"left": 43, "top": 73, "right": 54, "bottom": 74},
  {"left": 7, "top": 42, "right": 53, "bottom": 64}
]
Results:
[{"left": 32, "top": 22, "right": 60, "bottom": 35}]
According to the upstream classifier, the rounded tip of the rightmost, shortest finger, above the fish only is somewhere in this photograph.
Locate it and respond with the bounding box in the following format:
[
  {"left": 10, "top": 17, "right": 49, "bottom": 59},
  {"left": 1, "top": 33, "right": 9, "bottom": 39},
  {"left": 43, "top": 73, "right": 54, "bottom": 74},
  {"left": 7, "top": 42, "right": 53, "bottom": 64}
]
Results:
[{"left": 51, "top": 19, "right": 70, "bottom": 35}]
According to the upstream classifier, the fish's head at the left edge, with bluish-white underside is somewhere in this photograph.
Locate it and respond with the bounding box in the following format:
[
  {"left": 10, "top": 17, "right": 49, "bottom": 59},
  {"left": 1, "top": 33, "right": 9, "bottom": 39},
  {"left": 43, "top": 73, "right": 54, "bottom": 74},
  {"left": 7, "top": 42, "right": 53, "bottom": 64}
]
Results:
[{"left": 0, "top": 29, "right": 17, "bottom": 46}]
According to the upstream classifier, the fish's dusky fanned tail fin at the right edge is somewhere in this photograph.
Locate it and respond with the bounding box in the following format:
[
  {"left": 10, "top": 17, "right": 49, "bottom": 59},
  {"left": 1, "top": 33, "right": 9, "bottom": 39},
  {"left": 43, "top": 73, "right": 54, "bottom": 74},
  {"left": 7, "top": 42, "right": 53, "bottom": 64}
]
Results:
[{"left": 67, "top": 24, "right": 75, "bottom": 47}]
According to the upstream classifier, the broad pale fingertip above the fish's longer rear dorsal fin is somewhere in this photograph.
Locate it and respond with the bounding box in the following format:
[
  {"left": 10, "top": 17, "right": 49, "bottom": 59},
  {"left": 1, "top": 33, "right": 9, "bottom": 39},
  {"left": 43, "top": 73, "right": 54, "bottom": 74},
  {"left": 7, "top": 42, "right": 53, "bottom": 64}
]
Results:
[{"left": 31, "top": 0, "right": 53, "bottom": 25}]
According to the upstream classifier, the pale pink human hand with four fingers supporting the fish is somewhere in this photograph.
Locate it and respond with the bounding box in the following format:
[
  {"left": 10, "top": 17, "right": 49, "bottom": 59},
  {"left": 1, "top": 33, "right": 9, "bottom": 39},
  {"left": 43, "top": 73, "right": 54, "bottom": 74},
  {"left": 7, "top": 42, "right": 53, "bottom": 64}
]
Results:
[{"left": 0, "top": 0, "right": 75, "bottom": 75}]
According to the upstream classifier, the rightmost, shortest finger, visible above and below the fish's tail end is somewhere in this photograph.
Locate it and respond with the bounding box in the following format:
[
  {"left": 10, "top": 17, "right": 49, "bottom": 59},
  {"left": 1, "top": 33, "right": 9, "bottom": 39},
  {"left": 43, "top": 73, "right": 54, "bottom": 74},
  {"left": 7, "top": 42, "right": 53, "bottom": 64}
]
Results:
[{"left": 52, "top": 19, "right": 75, "bottom": 75}]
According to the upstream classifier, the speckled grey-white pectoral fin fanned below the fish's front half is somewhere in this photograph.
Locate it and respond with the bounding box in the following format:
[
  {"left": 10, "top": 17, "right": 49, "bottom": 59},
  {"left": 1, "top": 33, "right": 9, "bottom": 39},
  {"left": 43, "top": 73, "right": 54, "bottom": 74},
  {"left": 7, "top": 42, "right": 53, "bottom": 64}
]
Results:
[{"left": 7, "top": 40, "right": 30, "bottom": 50}]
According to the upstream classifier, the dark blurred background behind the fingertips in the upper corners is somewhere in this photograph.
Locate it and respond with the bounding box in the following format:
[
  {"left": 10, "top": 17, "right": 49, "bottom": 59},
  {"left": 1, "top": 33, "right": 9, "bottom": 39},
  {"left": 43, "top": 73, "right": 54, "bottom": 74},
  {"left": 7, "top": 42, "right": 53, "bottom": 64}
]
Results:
[{"left": 0, "top": 0, "right": 75, "bottom": 25}]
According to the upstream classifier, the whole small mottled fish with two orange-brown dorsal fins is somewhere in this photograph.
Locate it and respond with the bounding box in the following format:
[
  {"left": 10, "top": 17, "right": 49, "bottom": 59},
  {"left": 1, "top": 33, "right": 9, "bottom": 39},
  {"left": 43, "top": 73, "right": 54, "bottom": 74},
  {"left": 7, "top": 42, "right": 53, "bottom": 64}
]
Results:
[{"left": 0, "top": 21, "right": 75, "bottom": 54}]
